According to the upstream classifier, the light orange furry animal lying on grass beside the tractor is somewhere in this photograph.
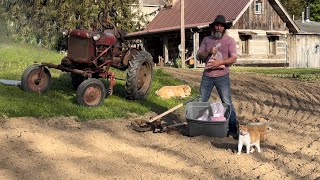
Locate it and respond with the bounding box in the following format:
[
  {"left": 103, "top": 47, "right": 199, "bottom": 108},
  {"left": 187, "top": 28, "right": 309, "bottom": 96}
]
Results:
[{"left": 156, "top": 85, "right": 191, "bottom": 99}]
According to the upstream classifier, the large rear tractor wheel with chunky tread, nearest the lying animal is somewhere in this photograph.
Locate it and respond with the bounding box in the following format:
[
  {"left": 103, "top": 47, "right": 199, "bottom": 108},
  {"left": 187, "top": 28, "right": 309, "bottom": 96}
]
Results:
[{"left": 125, "top": 51, "right": 153, "bottom": 99}]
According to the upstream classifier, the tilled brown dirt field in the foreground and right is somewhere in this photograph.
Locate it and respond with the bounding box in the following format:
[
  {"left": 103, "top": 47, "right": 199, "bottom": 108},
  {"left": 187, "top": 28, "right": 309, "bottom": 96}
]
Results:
[{"left": 0, "top": 69, "right": 320, "bottom": 180}]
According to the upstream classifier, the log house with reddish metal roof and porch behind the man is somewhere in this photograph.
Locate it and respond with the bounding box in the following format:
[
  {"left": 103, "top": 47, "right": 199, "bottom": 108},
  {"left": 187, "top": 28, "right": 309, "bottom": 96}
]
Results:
[{"left": 128, "top": 0, "right": 299, "bottom": 66}]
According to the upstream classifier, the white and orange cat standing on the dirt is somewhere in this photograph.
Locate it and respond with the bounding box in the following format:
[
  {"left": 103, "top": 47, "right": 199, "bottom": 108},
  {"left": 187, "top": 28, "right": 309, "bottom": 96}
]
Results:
[{"left": 238, "top": 124, "right": 261, "bottom": 154}]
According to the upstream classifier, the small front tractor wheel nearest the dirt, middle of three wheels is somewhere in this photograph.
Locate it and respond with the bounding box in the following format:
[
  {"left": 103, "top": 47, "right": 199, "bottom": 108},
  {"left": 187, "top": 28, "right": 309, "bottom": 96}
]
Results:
[{"left": 76, "top": 78, "right": 106, "bottom": 107}]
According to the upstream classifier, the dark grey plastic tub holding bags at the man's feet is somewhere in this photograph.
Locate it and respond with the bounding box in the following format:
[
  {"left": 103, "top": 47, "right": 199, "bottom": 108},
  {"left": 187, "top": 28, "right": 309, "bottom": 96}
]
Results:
[{"left": 185, "top": 102, "right": 231, "bottom": 137}]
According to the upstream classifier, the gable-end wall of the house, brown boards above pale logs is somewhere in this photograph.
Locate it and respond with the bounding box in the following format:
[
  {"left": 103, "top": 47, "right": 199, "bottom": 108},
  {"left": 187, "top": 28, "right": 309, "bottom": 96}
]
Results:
[{"left": 228, "top": 0, "right": 289, "bottom": 65}]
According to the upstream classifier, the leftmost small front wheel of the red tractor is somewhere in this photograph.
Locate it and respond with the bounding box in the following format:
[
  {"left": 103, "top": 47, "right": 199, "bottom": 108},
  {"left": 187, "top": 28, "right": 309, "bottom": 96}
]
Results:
[{"left": 21, "top": 64, "right": 51, "bottom": 93}]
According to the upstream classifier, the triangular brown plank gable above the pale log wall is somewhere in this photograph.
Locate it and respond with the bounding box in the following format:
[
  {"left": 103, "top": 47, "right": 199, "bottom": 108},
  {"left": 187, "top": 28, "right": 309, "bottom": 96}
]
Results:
[{"left": 232, "top": 0, "right": 288, "bottom": 31}]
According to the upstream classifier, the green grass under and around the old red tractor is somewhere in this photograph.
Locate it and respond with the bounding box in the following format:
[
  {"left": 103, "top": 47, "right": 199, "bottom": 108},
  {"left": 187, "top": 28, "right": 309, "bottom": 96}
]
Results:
[{"left": 0, "top": 41, "right": 197, "bottom": 120}]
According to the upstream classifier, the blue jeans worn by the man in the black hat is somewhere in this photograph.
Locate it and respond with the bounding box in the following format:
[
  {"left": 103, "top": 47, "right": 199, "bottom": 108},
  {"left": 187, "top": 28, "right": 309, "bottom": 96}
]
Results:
[{"left": 199, "top": 74, "right": 237, "bottom": 132}]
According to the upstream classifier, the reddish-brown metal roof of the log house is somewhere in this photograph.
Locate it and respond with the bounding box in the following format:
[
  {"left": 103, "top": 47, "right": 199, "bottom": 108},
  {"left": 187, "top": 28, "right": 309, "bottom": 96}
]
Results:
[{"left": 129, "top": 0, "right": 252, "bottom": 36}]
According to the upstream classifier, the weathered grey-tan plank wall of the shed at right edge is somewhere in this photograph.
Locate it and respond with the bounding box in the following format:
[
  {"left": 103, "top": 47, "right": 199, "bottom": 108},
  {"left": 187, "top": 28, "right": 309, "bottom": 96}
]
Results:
[{"left": 287, "top": 34, "right": 320, "bottom": 68}]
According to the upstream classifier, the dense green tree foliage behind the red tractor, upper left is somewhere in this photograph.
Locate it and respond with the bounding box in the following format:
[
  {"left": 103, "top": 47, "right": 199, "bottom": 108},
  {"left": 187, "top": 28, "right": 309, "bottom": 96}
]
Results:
[{"left": 0, "top": 0, "right": 144, "bottom": 49}]
